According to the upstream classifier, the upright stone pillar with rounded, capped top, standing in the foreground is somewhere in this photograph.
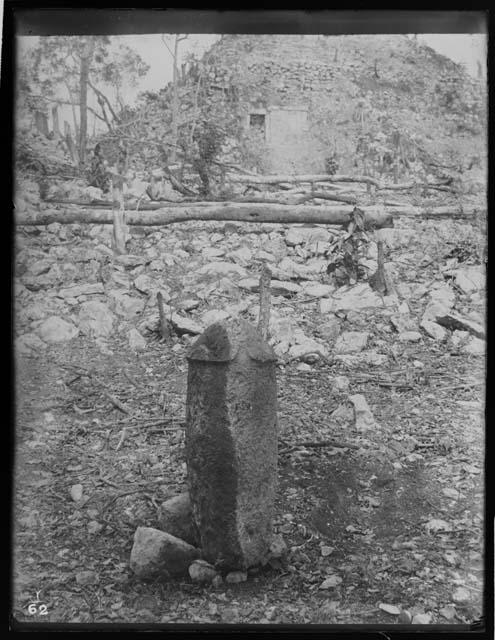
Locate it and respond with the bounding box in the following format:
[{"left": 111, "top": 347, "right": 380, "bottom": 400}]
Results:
[{"left": 186, "top": 319, "right": 277, "bottom": 569}]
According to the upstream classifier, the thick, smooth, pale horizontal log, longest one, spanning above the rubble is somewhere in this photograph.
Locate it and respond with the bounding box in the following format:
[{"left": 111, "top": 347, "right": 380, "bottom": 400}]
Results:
[{"left": 15, "top": 203, "right": 393, "bottom": 229}]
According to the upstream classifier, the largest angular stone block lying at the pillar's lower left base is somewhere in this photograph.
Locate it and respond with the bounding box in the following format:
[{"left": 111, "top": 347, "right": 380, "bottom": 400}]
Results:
[{"left": 130, "top": 527, "right": 200, "bottom": 579}]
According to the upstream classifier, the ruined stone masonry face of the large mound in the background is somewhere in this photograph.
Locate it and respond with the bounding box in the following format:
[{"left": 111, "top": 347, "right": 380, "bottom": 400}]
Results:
[{"left": 192, "top": 35, "right": 486, "bottom": 171}]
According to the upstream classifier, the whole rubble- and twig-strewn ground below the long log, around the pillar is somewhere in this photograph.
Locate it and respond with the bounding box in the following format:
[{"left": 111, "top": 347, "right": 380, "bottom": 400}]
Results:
[{"left": 14, "top": 214, "right": 485, "bottom": 624}]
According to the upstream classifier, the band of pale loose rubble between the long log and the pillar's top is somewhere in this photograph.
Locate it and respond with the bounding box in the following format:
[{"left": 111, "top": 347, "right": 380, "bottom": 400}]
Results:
[{"left": 15, "top": 212, "right": 485, "bottom": 366}]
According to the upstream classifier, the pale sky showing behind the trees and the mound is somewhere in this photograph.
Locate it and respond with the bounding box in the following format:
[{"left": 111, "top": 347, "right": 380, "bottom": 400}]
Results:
[{"left": 17, "top": 33, "right": 487, "bottom": 131}]
